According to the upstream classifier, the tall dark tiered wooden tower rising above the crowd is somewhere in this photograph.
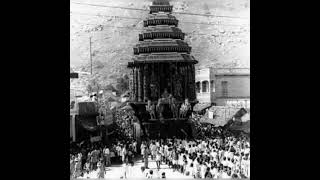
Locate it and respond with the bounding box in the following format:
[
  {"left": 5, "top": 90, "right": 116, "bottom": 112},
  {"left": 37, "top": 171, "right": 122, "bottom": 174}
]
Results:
[{"left": 128, "top": 0, "right": 198, "bottom": 138}]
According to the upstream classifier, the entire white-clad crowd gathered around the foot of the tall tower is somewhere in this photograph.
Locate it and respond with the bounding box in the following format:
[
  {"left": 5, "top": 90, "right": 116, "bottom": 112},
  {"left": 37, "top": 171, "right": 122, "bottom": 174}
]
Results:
[{"left": 70, "top": 105, "right": 250, "bottom": 179}]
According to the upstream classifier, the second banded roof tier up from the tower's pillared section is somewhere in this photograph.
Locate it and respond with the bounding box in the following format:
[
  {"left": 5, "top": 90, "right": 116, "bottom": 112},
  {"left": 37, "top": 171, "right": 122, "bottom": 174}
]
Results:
[{"left": 139, "top": 25, "right": 185, "bottom": 41}]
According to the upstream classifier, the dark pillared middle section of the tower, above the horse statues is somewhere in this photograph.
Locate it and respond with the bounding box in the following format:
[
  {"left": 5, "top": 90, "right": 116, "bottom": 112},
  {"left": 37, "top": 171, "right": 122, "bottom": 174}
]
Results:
[{"left": 128, "top": 61, "right": 197, "bottom": 102}]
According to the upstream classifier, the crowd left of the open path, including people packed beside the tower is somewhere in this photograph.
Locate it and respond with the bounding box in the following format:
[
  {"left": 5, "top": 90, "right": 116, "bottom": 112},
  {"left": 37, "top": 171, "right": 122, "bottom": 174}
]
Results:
[{"left": 70, "top": 104, "right": 137, "bottom": 178}]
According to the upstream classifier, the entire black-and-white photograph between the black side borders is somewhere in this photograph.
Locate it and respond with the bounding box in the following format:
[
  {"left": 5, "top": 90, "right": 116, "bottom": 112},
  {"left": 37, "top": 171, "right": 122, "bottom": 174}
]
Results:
[{"left": 70, "top": 0, "right": 250, "bottom": 179}]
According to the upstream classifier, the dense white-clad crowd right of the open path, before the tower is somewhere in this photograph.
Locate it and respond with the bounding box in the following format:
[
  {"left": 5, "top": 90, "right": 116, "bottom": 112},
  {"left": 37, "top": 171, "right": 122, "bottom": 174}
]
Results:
[{"left": 141, "top": 132, "right": 250, "bottom": 179}]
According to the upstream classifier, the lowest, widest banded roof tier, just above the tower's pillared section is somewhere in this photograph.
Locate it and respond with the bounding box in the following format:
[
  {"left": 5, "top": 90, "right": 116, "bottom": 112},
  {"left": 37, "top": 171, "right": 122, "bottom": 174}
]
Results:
[{"left": 133, "top": 39, "right": 191, "bottom": 55}]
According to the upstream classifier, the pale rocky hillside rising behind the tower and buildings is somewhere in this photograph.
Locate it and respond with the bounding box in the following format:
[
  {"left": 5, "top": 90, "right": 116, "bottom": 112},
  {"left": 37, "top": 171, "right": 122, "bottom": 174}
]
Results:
[{"left": 70, "top": 0, "right": 250, "bottom": 94}]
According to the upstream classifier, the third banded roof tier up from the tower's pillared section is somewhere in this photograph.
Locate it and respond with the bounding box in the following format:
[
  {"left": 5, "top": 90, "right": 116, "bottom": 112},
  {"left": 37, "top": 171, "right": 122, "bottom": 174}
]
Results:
[{"left": 143, "top": 12, "right": 179, "bottom": 27}]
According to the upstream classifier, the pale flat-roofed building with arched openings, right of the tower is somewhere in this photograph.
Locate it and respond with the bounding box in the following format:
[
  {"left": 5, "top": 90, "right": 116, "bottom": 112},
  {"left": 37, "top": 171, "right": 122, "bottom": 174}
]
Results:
[{"left": 196, "top": 68, "right": 250, "bottom": 108}]
